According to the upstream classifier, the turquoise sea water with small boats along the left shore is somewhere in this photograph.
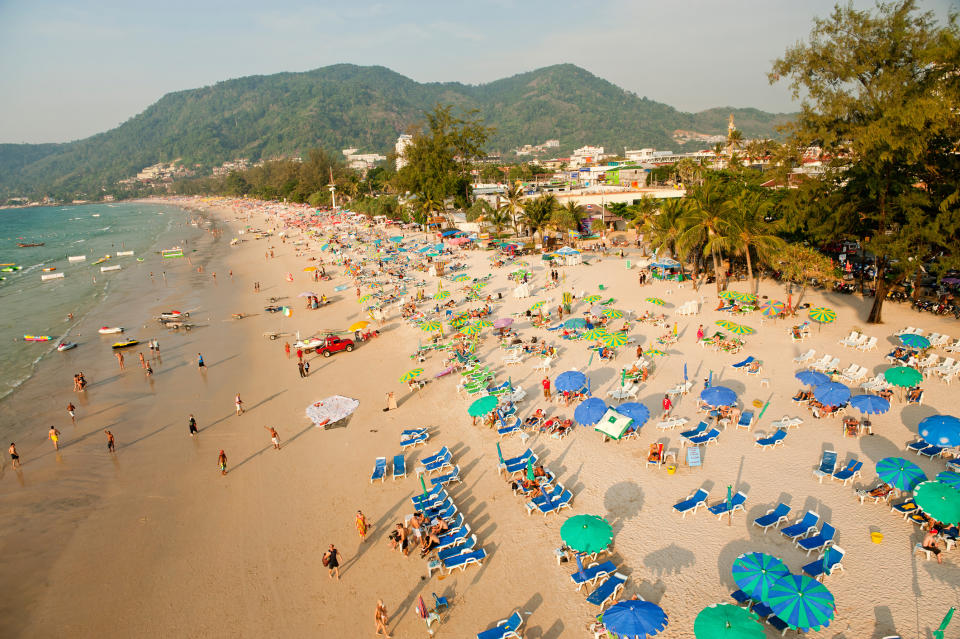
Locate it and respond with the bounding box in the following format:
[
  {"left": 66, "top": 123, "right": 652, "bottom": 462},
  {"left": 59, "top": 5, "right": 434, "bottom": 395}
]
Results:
[{"left": 0, "top": 203, "right": 187, "bottom": 398}]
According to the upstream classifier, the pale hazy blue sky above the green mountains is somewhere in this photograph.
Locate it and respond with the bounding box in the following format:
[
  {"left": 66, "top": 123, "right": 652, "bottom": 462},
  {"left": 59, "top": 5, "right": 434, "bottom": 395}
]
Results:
[{"left": 0, "top": 0, "right": 957, "bottom": 142}]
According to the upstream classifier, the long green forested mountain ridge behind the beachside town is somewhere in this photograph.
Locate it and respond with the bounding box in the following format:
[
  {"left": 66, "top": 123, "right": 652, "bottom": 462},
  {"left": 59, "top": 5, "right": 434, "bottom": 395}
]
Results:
[{"left": 0, "top": 64, "right": 787, "bottom": 196}]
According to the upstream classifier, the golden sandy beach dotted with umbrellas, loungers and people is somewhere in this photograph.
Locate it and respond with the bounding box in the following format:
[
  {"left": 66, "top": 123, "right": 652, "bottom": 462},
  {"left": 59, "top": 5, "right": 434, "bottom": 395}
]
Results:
[{"left": 0, "top": 200, "right": 960, "bottom": 639}]
